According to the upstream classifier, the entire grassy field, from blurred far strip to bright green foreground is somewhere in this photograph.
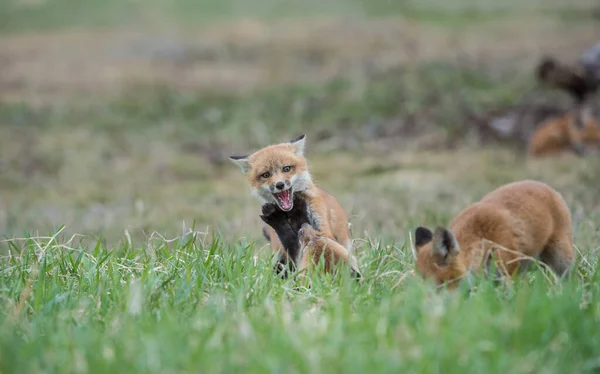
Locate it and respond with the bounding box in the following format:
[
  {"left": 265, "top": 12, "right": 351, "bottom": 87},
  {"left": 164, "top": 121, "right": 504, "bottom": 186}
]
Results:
[{"left": 0, "top": 0, "right": 600, "bottom": 374}]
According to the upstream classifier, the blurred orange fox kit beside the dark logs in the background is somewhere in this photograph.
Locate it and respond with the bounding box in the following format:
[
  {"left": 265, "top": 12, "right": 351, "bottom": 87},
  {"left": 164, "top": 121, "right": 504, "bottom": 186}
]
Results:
[{"left": 528, "top": 107, "right": 600, "bottom": 157}]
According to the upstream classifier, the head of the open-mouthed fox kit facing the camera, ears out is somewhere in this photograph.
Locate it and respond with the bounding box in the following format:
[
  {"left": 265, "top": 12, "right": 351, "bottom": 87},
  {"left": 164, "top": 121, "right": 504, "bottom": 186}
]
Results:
[{"left": 230, "top": 135, "right": 311, "bottom": 212}]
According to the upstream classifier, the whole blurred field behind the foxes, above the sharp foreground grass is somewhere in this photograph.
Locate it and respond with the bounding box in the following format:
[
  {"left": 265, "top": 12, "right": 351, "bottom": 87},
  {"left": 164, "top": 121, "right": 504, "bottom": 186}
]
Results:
[{"left": 0, "top": 0, "right": 600, "bottom": 247}]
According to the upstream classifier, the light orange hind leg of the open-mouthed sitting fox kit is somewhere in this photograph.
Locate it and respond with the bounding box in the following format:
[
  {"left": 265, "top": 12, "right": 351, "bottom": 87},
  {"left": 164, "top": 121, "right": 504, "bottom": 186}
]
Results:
[{"left": 298, "top": 223, "right": 362, "bottom": 279}]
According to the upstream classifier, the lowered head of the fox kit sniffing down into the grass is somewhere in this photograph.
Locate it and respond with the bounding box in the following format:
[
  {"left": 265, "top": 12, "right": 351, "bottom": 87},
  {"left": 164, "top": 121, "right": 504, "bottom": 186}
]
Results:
[{"left": 415, "top": 227, "right": 468, "bottom": 289}]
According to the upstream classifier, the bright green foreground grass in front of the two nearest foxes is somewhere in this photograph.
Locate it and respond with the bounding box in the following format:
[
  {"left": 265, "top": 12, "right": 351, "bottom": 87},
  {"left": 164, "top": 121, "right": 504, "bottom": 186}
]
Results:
[{"left": 0, "top": 226, "right": 600, "bottom": 373}]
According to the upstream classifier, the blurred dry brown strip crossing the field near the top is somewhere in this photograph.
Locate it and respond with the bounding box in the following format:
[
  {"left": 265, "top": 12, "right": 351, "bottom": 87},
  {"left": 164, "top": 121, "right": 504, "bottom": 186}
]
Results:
[{"left": 0, "top": 18, "right": 600, "bottom": 101}]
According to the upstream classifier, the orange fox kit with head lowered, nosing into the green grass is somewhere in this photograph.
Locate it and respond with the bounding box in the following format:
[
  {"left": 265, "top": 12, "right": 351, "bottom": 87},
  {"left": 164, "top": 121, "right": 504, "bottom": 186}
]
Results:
[{"left": 415, "top": 181, "right": 574, "bottom": 288}]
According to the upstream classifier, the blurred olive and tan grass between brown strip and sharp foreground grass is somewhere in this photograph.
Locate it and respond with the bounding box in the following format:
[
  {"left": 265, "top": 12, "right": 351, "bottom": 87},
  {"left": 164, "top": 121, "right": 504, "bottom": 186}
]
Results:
[{"left": 0, "top": 63, "right": 595, "bottom": 242}]
